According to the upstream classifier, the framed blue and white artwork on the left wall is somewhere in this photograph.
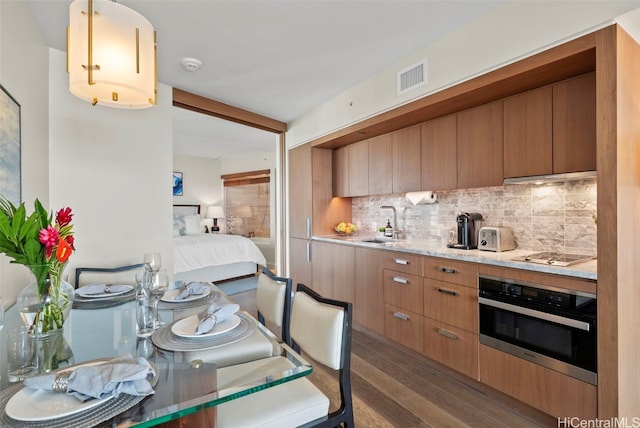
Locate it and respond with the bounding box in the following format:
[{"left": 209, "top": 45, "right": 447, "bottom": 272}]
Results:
[{"left": 0, "top": 85, "right": 22, "bottom": 206}]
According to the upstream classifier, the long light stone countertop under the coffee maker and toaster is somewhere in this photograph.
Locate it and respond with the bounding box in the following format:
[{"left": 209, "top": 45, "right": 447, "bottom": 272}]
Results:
[{"left": 312, "top": 235, "right": 598, "bottom": 281}]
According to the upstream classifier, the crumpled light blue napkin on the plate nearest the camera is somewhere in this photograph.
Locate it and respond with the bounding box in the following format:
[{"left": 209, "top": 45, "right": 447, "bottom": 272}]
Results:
[{"left": 24, "top": 354, "right": 154, "bottom": 401}]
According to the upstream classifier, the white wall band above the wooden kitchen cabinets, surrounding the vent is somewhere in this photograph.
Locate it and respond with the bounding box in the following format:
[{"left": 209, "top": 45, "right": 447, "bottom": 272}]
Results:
[{"left": 286, "top": 0, "right": 640, "bottom": 148}]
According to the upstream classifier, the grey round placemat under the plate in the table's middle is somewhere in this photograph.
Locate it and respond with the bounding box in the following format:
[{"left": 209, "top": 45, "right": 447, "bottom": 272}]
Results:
[{"left": 151, "top": 312, "right": 257, "bottom": 352}]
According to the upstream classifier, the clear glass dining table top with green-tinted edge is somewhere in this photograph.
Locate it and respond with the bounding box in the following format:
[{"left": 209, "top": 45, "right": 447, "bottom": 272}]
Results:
[{"left": 0, "top": 286, "right": 312, "bottom": 428}]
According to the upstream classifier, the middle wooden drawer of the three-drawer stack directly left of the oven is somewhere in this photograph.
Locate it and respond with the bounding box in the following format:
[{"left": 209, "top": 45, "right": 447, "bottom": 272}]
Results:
[{"left": 422, "top": 278, "right": 478, "bottom": 334}]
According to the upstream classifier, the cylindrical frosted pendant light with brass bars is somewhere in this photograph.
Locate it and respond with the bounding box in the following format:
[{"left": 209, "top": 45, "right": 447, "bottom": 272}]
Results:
[{"left": 67, "top": 0, "right": 157, "bottom": 109}]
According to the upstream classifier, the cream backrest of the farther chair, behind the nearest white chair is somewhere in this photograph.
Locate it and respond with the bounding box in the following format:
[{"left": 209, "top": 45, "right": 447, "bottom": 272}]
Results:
[{"left": 256, "top": 267, "right": 292, "bottom": 345}]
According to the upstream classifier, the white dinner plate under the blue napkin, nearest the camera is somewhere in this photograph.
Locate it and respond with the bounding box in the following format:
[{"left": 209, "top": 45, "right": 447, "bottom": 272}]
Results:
[{"left": 4, "top": 363, "right": 114, "bottom": 422}]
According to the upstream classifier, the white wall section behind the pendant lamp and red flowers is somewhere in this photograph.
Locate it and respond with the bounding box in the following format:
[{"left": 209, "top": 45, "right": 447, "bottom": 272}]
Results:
[{"left": 49, "top": 49, "right": 173, "bottom": 284}]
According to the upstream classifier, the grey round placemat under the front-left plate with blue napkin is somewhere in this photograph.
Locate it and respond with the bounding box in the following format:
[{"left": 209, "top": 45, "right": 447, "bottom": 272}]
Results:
[{"left": 0, "top": 358, "right": 158, "bottom": 428}]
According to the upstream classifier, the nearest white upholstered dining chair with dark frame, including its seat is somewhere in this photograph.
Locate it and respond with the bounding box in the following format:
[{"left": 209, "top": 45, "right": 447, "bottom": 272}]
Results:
[{"left": 216, "top": 284, "right": 354, "bottom": 428}]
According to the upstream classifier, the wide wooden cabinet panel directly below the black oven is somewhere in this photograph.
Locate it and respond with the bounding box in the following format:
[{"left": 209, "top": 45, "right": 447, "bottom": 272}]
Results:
[{"left": 479, "top": 345, "right": 598, "bottom": 420}]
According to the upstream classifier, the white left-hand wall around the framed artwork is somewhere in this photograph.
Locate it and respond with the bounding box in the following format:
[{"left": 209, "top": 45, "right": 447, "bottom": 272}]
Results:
[{"left": 0, "top": 1, "right": 49, "bottom": 306}]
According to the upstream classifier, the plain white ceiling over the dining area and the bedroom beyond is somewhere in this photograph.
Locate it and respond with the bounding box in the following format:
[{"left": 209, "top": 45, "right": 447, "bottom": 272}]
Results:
[{"left": 27, "top": 0, "right": 505, "bottom": 157}]
